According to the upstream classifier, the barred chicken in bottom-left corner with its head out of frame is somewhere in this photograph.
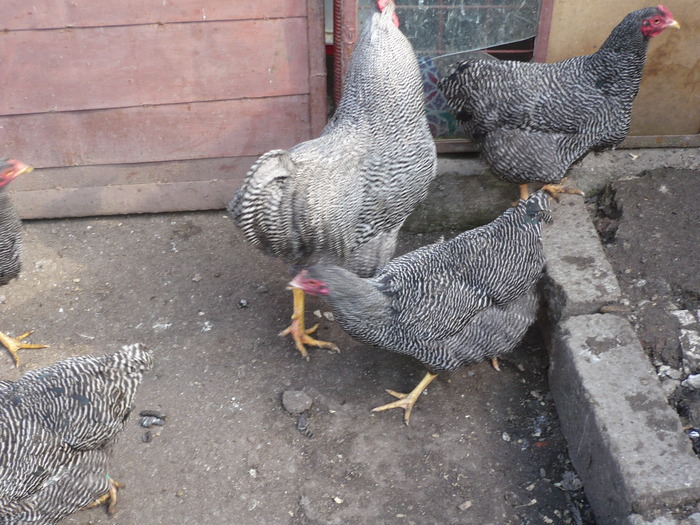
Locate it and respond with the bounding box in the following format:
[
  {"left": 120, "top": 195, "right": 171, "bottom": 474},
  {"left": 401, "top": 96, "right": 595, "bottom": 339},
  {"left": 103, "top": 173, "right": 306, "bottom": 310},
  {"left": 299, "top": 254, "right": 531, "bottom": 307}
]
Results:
[{"left": 0, "top": 344, "right": 153, "bottom": 525}]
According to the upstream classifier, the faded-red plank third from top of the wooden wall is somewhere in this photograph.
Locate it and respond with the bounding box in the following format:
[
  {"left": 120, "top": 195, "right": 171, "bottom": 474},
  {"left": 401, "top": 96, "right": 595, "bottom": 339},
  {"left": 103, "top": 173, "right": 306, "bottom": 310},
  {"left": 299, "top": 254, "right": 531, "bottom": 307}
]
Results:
[{"left": 0, "top": 95, "right": 310, "bottom": 167}]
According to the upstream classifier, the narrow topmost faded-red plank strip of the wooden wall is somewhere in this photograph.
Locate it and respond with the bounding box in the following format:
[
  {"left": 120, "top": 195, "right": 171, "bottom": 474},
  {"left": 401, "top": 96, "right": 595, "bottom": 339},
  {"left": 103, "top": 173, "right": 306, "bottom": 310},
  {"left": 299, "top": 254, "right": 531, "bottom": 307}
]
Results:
[{"left": 0, "top": 0, "right": 306, "bottom": 30}]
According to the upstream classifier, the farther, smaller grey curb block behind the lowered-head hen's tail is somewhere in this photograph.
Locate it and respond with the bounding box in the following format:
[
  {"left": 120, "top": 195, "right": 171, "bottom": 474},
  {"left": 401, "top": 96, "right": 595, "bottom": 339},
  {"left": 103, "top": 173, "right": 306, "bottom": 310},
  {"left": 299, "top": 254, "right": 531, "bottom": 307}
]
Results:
[{"left": 542, "top": 195, "right": 621, "bottom": 320}]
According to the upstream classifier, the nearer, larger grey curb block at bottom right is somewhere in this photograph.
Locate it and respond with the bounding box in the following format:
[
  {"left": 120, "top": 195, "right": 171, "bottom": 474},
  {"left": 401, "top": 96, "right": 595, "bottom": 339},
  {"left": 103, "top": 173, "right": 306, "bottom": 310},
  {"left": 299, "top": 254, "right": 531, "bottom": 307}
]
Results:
[{"left": 549, "top": 314, "right": 700, "bottom": 525}]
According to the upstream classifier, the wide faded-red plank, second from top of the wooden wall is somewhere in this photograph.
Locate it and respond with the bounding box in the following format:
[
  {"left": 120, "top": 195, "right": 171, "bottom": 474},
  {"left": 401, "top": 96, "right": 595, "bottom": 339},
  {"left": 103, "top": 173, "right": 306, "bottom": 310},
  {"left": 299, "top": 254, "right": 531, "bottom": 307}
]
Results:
[{"left": 0, "top": 18, "right": 310, "bottom": 115}]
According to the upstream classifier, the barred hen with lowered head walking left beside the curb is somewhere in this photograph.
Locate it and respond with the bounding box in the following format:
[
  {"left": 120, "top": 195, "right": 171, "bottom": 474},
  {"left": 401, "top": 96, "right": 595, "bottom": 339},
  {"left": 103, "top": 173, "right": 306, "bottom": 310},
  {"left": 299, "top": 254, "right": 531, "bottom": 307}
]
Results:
[{"left": 290, "top": 191, "right": 550, "bottom": 424}]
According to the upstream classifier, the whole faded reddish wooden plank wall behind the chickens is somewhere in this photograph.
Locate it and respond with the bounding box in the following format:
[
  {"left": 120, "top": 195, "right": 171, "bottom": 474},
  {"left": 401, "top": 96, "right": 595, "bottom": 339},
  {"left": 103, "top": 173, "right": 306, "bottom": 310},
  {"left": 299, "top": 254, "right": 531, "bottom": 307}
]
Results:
[{"left": 0, "top": 0, "right": 326, "bottom": 218}]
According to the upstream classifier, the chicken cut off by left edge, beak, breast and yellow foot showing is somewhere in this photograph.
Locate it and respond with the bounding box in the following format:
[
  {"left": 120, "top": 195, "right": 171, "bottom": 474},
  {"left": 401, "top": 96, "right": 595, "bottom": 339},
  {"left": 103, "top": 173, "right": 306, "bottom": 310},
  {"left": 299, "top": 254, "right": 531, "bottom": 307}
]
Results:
[{"left": 0, "top": 159, "right": 46, "bottom": 366}]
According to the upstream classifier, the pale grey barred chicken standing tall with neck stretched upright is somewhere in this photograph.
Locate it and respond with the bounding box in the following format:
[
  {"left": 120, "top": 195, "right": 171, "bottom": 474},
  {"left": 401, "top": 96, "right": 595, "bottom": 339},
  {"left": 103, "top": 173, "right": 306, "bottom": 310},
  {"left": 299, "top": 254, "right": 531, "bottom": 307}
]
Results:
[{"left": 228, "top": 0, "right": 437, "bottom": 358}]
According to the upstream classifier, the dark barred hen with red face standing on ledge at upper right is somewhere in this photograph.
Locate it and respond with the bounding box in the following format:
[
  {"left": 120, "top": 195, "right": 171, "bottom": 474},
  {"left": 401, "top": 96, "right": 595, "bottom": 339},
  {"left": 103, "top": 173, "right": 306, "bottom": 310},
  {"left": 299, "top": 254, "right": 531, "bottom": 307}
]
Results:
[{"left": 440, "top": 5, "right": 680, "bottom": 198}]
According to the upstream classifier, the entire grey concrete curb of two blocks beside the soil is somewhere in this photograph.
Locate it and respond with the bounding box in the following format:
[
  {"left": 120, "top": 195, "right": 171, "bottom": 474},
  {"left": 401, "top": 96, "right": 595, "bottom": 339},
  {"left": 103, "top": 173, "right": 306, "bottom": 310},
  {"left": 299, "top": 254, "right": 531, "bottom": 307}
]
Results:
[{"left": 543, "top": 196, "right": 700, "bottom": 525}]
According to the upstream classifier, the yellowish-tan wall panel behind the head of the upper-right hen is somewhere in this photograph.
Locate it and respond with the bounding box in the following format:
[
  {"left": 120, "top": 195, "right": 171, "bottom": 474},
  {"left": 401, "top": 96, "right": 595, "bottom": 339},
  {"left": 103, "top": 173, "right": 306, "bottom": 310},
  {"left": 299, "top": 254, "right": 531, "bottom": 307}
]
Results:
[{"left": 546, "top": 0, "right": 700, "bottom": 135}]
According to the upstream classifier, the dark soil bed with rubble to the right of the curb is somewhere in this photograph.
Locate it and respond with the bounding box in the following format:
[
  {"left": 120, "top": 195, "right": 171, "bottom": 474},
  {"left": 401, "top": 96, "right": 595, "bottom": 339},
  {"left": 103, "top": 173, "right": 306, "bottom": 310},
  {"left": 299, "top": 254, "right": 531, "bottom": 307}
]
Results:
[{"left": 591, "top": 169, "right": 700, "bottom": 450}]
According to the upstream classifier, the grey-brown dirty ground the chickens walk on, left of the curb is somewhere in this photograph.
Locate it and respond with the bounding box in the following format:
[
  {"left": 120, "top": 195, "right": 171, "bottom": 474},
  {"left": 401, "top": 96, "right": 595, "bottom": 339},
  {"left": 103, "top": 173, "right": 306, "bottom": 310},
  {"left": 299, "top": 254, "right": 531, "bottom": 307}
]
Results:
[{"left": 0, "top": 212, "right": 592, "bottom": 525}]
